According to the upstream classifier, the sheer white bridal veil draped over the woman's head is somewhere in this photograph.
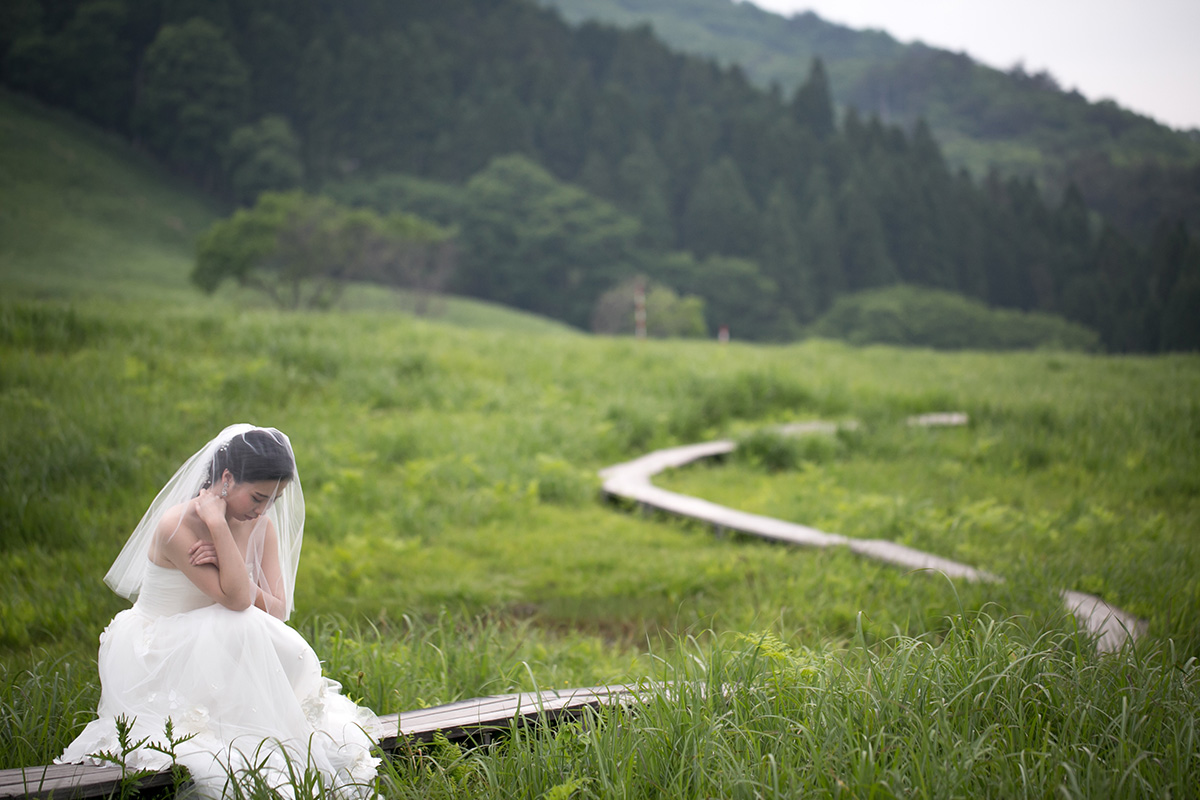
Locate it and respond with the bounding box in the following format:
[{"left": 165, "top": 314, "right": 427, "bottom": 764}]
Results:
[{"left": 104, "top": 423, "right": 304, "bottom": 619}]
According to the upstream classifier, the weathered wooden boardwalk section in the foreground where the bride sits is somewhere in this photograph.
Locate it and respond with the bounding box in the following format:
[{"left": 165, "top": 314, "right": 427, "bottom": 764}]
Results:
[{"left": 0, "top": 685, "right": 638, "bottom": 799}]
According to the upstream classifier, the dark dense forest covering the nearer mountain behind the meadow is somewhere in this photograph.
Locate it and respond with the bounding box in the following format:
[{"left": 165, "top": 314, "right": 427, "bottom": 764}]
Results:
[{"left": 7, "top": 0, "right": 1200, "bottom": 351}]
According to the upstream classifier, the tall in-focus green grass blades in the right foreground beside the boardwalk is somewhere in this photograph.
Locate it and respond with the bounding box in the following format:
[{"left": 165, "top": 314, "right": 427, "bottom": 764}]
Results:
[{"left": 384, "top": 615, "right": 1200, "bottom": 798}]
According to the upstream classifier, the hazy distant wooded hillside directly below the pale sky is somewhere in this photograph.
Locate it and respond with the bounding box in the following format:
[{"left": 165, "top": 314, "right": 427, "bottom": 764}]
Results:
[{"left": 540, "top": 0, "right": 1200, "bottom": 234}]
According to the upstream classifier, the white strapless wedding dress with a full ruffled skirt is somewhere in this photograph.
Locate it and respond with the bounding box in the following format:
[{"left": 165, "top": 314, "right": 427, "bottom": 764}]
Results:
[{"left": 58, "top": 564, "right": 379, "bottom": 798}]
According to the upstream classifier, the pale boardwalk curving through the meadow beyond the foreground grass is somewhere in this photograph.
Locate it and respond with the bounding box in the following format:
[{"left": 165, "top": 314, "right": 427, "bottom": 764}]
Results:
[{"left": 600, "top": 413, "right": 1146, "bottom": 652}]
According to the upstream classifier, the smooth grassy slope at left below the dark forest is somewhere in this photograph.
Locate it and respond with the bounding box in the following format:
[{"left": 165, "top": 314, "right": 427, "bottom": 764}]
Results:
[{"left": 0, "top": 91, "right": 571, "bottom": 335}]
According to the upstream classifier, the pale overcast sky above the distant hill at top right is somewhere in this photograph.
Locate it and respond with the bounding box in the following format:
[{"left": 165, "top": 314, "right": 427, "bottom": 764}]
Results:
[{"left": 750, "top": 0, "right": 1200, "bottom": 128}]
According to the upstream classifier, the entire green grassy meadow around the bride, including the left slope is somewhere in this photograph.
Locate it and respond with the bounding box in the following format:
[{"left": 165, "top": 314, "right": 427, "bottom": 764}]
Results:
[{"left": 0, "top": 96, "right": 1200, "bottom": 798}]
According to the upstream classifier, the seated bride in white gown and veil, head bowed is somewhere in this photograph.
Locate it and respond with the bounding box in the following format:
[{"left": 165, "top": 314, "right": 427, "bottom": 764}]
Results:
[{"left": 56, "top": 425, "right": 379, "bottom": 798}]
